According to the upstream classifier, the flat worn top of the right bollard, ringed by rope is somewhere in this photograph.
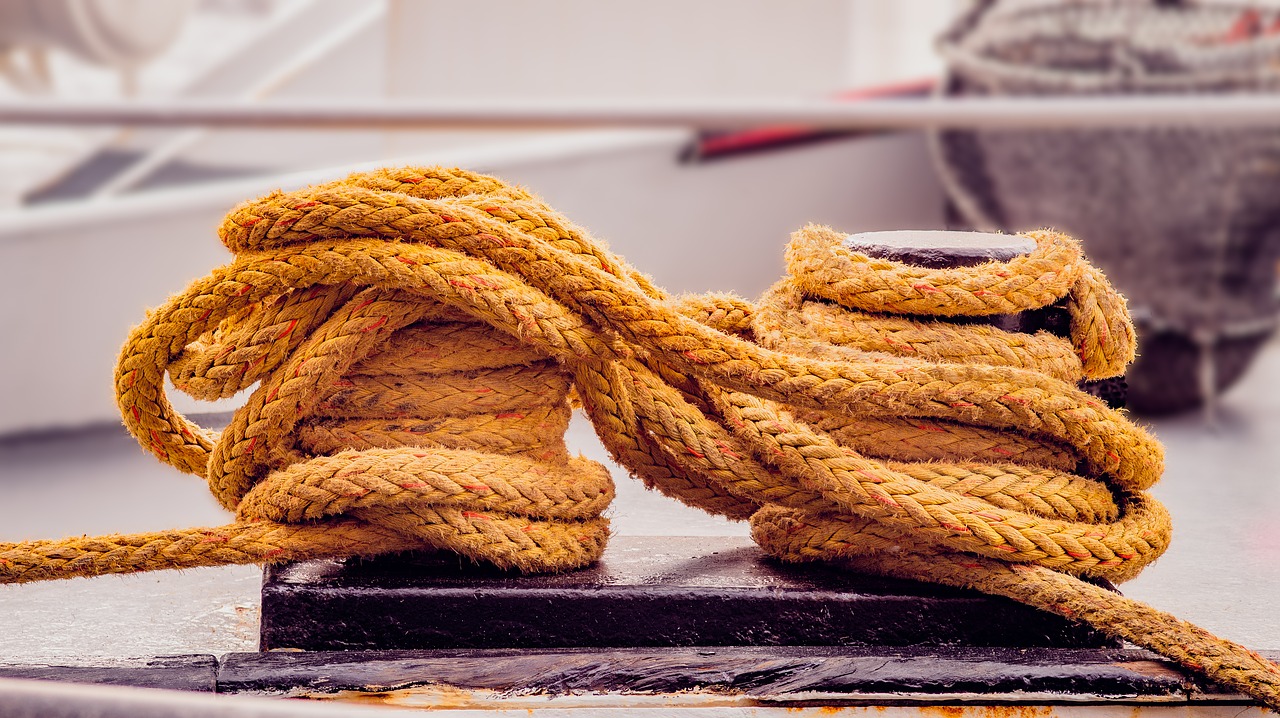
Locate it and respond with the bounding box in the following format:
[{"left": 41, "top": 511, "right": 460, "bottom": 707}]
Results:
[{"left": 845, "top": 229, "right": 1036, "bottom": 269}]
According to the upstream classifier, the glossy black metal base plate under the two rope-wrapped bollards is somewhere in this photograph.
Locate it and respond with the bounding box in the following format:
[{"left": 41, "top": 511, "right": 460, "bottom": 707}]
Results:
[{"left": 261, "top": 536, "right": 1117, "bottom": 650}]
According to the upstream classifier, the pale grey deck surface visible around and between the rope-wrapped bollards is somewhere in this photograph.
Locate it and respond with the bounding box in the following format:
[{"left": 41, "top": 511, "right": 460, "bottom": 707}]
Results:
[{"left": 0, "top": 344, "right": 1280, "bottom": 660}]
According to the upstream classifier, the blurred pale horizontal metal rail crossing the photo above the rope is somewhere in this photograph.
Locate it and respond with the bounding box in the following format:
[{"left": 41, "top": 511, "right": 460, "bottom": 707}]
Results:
[{"left": 0, "top": 95, "right": 1280, "bottom": 129}]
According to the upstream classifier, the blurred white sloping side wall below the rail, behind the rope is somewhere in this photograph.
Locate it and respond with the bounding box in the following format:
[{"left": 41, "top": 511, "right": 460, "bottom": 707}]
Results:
[{"left": 0, "top": 133, "right": 942, "bottom": 434}]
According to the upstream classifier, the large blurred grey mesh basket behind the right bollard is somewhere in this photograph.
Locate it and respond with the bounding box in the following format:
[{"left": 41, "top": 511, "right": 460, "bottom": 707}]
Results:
[{"left": 933, "top": 1, "right": 1280, "bottom": 411}]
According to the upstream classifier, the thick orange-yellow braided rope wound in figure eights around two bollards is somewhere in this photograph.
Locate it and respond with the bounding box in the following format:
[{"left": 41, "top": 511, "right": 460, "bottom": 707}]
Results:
[{"left": 0, "top": 168, "right": 1280, "bottom": 708}]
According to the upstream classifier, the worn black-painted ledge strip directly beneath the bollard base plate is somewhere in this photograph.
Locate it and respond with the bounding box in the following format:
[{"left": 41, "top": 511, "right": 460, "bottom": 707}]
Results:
[{"left": 219, "top": 648, "right": 1193, "bottom": 700}]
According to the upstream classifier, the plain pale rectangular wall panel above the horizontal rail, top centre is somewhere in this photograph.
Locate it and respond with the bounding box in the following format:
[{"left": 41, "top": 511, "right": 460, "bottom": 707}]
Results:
[{"left": 388, "top": 0, "right": 855, "bottom": 99}]
